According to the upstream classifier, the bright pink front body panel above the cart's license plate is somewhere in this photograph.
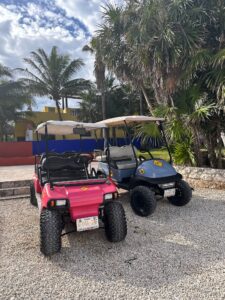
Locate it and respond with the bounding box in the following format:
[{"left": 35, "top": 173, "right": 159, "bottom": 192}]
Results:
[{"left": 42, "top": 179, "right": 117, "bottom": 221}]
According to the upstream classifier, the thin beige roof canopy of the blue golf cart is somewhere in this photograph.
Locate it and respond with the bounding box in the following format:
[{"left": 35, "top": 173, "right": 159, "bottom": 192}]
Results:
[{"left": 96, "top": 116, "right": 165, "bottom": 126}]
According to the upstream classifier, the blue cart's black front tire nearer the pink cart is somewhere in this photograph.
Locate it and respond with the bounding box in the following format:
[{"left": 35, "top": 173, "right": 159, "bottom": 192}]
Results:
[{"left": 130, "top": 185, "right": 156, "bottom": 217}]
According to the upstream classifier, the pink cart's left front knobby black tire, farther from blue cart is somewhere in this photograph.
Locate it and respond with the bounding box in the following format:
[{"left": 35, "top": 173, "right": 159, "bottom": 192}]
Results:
[{"left": 40, "top": 209, "right": 63, "bottom": 256}]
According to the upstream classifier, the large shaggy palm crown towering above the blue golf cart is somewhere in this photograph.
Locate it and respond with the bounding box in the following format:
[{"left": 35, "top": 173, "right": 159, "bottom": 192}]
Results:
[{"left": 97, "top": 0, "right": 208, "bottom": 111}]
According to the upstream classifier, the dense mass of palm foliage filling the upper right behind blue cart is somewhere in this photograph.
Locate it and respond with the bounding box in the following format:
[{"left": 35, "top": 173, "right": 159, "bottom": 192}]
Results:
[{"left": 88, "top": 0, "right": 225, "bottom": 167}]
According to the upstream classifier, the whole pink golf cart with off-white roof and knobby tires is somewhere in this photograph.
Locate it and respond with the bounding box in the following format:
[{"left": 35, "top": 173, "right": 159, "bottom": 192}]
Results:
[{"left": 30, "top": 121, "right": 127, "bottom": 255}]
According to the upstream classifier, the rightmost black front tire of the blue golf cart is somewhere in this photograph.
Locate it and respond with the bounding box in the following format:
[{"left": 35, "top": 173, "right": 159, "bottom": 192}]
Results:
[{"left": 168, "top": 180, "right": 192, "bottom": 206}]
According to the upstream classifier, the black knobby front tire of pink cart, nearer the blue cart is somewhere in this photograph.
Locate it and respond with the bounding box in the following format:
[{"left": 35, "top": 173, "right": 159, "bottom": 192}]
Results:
[{"left": 104, "top": 201, "right": 127, "bottom": 243}]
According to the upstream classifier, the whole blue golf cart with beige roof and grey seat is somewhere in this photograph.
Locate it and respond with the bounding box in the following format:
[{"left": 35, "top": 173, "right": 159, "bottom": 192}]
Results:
[{"left": 97, "top": 116, "right": 192, "bottom": 216}]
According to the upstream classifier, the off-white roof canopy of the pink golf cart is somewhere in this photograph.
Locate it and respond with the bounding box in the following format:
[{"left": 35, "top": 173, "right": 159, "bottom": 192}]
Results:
[{"left": 36, "top": 121, "right": 106, "bottom": 135}]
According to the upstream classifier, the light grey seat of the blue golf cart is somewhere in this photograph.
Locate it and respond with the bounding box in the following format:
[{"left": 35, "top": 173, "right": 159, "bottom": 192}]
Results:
[{"left": 109, "top": 145, "right": 136, "bottom": 170}]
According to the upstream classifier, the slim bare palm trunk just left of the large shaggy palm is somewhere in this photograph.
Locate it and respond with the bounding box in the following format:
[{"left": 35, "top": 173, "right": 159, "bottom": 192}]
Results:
[{"left": 83, "top": 38, "right": 106, "bottom": 120}]
